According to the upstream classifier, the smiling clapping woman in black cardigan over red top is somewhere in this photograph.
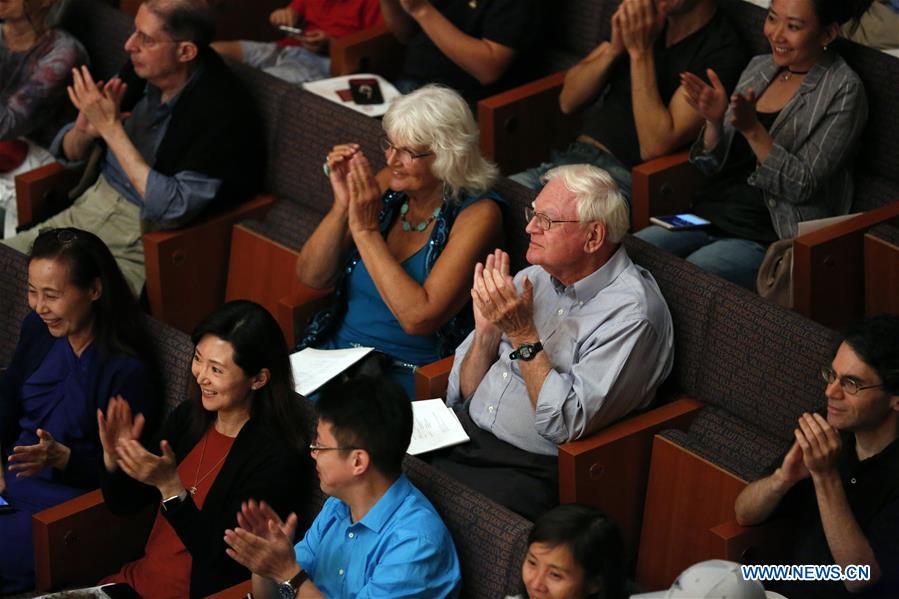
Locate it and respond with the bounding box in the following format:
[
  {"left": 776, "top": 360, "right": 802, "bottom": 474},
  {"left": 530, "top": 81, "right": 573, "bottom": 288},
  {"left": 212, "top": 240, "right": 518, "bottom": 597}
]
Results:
[{"left": 97, "top": 301, "right": 311, "bottom": 597}]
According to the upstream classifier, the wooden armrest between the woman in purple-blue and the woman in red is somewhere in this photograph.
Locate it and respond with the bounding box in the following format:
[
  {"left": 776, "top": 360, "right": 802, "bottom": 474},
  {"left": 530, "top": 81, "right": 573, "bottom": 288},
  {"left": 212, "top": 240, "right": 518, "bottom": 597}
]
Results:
[{"left": 31, "top": 490, "right": 157, "bottom": 592}]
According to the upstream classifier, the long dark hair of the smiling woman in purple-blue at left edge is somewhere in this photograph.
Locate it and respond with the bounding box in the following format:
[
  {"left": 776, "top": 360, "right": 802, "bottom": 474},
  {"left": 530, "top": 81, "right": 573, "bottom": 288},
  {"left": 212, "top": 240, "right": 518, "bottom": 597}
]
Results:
[{"left": 30, "top": 227, "right": 156, "bottom": 372}]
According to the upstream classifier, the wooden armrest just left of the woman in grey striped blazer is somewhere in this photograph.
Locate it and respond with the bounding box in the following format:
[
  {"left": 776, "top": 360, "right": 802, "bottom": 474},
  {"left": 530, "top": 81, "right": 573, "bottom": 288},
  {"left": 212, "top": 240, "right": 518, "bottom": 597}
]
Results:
[{"left": 631, "top": 152, "right": 702, "bottom": 231}]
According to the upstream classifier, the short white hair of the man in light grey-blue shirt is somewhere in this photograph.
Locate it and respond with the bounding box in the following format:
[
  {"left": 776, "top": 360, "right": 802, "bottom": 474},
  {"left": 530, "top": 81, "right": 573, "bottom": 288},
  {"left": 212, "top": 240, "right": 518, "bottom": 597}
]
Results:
[{"left": 543, "top": 164, "right": 631, "bottom": 243}]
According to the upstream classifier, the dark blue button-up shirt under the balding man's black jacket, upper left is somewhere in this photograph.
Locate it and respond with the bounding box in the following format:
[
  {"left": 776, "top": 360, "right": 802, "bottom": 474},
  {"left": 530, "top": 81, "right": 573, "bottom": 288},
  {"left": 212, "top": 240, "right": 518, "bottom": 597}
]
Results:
[{"left": 50, "top": 67, "right": 222, "bottom": 228}]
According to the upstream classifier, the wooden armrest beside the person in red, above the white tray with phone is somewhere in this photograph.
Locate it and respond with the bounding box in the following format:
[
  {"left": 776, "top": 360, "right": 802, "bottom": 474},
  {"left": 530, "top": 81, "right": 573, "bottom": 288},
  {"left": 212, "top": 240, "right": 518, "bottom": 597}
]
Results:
[{"left": 331, "top": 25, "right": 405, "bottom": 79}]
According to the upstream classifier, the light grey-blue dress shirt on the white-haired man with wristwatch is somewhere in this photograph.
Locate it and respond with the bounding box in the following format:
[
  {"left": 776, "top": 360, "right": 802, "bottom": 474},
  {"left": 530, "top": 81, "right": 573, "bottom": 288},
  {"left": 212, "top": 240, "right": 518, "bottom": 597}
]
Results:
[{"left": 446, "top": 247, "right": 674, "bottom": 455}]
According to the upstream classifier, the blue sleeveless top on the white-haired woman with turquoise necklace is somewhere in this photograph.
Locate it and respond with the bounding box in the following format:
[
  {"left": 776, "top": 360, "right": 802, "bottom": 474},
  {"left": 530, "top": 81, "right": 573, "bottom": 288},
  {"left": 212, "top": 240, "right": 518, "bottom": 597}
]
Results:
[{"left": 297, "top": 190, "right": 505, "bottom": 366}]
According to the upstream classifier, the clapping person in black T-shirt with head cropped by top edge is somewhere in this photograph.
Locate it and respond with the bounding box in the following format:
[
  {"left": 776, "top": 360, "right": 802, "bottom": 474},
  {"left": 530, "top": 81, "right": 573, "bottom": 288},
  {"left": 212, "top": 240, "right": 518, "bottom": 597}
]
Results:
[{"left": 512, "top": 0, "right": 747, "bottom": 199}]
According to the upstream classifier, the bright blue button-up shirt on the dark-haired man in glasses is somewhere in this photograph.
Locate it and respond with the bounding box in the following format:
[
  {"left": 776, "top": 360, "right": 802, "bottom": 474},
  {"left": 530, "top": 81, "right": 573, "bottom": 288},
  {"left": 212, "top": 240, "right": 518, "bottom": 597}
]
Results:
[{"left": 294, "top": 475, "right": 461, "bottom": 599}]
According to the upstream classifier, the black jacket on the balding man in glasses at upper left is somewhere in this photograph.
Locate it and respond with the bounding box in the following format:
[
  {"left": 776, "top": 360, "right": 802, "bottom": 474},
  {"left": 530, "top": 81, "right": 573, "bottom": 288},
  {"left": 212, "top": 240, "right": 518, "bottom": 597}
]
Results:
[{"left": 119, "top": 48, "right": 265, "bottom": 216}]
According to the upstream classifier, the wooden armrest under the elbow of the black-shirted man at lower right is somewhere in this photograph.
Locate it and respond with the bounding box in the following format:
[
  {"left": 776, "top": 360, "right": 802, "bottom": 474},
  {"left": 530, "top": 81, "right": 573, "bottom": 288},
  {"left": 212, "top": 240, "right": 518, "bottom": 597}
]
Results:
[{"left": 708, "top": 519, "right": 795, "bottom": 564}]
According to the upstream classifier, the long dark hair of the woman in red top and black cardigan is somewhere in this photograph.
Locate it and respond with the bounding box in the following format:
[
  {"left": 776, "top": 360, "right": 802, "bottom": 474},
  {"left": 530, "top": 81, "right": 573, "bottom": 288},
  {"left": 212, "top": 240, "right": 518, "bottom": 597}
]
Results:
[{"left": 190, "top": 300, "right": 308, "bottom": 452}]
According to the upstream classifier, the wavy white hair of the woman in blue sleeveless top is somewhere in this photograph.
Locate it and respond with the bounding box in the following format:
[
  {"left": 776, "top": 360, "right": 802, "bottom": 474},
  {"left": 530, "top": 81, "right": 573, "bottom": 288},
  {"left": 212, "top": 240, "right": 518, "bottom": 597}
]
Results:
[{"left": 383, "top": 85, "right": 499, "bottom": 199}]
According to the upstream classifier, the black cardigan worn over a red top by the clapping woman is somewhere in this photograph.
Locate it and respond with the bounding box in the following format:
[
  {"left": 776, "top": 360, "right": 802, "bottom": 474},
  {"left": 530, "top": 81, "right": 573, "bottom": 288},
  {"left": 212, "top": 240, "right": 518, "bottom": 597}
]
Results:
[{"left": 101, "top": 401, "right": 315, "bottom": 597}]
